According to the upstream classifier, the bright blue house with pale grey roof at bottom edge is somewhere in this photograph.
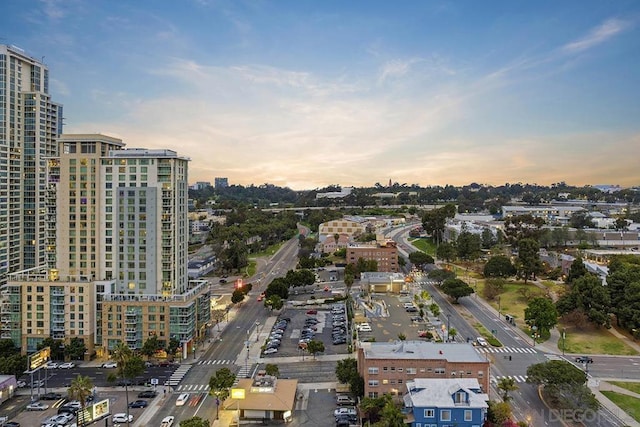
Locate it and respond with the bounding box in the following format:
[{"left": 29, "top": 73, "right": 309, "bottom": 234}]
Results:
[{"left": 403, "top": 378, "right": 489, "bottom": 427}]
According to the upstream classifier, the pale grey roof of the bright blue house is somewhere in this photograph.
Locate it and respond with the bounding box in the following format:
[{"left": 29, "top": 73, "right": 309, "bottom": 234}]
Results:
[{"left": 404, "top": 378, "right": 489, "bottom": 408}]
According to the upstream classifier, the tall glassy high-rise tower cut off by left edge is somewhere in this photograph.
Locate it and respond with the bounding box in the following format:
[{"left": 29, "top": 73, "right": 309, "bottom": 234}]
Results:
[{"left": 0, "top": 45, "right": 62, "bottom": 285}]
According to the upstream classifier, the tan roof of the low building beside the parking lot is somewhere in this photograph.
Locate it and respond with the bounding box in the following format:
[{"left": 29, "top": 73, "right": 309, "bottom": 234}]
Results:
[{"left": 223, "top": 378, "right": 298, "bottom": 411}]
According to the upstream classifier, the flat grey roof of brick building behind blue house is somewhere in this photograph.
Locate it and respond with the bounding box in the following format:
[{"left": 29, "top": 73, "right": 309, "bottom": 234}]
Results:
[{"left": 362, "top": 341, "right": 489, "bottom": 363}]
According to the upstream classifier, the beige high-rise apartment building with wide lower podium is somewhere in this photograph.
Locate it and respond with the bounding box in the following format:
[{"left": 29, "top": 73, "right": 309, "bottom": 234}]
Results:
[{"left": 2, "top": 135, "right": 210, "bottom": 357}]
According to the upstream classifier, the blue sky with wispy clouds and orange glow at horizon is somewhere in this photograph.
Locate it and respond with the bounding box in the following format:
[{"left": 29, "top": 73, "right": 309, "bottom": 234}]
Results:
[{"left": 0, "top": 0, "right": 640, "bottom": 190}]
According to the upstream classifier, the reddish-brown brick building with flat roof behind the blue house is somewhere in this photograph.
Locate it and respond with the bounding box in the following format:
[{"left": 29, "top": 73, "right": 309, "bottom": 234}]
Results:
[{"left": 358, "top": 341, "right": 490, "bottom": 398}]
